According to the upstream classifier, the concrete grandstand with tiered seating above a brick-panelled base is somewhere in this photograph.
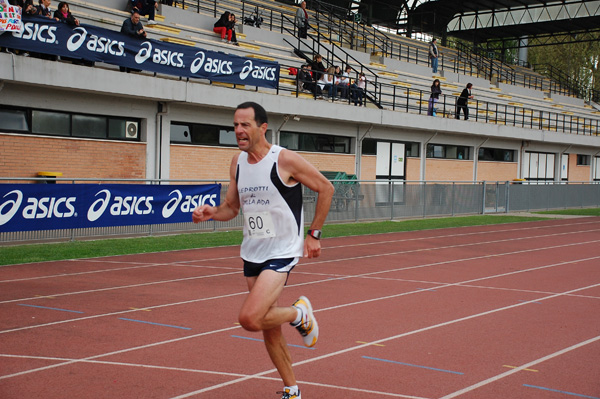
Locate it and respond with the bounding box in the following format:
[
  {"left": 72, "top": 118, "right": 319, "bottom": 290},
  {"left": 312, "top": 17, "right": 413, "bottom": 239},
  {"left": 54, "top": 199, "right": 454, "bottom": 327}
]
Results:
[{"left": 0, "top": 0, "right": 600, "bottom": 241}]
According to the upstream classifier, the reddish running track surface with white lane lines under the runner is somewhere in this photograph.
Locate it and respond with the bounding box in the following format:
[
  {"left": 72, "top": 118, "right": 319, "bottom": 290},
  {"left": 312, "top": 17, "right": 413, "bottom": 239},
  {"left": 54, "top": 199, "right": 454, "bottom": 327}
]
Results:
[{"left": 0, "top": 218, "right": 600, "bottom": 399}]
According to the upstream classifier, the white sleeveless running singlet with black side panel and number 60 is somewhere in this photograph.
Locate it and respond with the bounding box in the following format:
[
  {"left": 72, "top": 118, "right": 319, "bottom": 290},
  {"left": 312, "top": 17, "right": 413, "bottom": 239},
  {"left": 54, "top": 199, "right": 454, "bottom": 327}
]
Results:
[{"left": 235, "top": 145, "right": 304, "bottom": 263}]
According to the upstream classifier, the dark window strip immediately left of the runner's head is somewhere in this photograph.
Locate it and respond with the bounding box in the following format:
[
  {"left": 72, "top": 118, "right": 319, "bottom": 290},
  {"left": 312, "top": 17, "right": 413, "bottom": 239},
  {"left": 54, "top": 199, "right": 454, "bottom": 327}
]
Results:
[{"left": 171, "top": 122, "right": 237, "bottom": 147}]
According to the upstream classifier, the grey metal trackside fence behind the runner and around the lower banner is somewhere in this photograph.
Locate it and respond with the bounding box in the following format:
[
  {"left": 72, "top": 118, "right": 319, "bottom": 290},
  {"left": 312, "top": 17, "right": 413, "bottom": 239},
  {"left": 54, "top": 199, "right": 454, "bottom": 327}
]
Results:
[{"left": 0, "top": 177, "right": 600, "bottom": 244}]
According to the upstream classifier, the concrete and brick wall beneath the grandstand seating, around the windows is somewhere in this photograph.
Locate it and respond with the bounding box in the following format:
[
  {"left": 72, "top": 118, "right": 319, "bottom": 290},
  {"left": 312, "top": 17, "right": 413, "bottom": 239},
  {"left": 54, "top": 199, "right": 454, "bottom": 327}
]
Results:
[{"left": 0, "top": 38, "right": 600, "bottom": 186}]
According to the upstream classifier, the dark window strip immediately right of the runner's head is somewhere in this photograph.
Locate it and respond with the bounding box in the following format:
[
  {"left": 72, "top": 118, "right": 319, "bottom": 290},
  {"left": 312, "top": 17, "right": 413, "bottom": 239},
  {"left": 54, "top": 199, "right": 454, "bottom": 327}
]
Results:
[{"left": 279, "top": 132, "right": 351, "bottom": 154}]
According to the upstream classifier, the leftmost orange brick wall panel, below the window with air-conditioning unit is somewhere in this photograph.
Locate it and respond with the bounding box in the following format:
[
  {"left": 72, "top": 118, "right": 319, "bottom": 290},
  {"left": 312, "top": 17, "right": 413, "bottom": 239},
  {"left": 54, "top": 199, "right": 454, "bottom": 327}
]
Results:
[{"left": 0, "top": 134, "right": 146, "bottom": 179}]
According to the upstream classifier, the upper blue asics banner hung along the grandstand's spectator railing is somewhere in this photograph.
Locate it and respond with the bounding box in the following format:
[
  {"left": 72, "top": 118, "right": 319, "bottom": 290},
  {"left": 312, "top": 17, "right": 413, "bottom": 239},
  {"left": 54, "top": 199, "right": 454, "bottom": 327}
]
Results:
[{"left": 0, "top": 17, "right": 279, "bottom": 88}]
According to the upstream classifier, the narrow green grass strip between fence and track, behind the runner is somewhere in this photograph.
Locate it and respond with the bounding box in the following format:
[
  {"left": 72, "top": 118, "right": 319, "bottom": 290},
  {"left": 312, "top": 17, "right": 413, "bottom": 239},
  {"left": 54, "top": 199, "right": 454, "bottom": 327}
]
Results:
[{"left": 0, "top": 215, "right": 547, "bottom": 265}]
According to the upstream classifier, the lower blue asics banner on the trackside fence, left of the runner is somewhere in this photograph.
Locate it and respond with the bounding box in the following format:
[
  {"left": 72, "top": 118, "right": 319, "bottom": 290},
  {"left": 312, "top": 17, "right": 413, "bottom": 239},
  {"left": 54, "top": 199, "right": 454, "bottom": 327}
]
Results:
[{"left": 0, "top": 184, "right": 221, "bottom": 232}]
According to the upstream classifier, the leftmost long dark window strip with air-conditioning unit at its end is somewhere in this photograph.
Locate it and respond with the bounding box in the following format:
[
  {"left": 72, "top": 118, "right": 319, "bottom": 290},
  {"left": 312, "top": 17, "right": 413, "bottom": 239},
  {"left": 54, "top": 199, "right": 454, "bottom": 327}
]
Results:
[{"left": 0, "top": 105, "right": 139, "bottom": 141}]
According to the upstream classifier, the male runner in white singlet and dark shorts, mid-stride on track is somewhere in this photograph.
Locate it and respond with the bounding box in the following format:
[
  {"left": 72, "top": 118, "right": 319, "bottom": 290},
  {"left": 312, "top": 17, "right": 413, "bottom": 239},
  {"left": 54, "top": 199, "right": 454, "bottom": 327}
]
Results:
[{"left": 192, "top": 102, "right": 334, "bottom": 399}]
